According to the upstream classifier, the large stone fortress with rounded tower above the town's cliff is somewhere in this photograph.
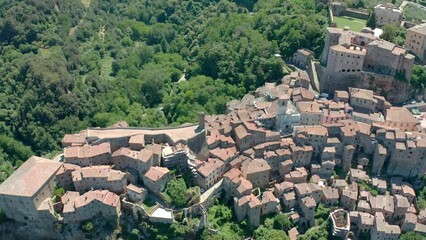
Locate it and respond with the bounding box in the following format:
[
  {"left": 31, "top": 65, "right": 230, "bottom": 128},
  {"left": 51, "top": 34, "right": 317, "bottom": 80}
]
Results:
[{"left": 321, "top": 28, "right": 414, "bottom": 82}]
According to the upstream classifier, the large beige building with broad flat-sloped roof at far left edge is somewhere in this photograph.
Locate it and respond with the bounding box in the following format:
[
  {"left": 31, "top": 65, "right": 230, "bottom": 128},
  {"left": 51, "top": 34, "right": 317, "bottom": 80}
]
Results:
[{"left": 0, "top": 156, "right": 63, "bottom": 223}]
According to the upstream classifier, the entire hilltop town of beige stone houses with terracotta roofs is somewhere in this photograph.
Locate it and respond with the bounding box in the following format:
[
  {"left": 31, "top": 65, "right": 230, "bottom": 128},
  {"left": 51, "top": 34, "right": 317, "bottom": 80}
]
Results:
[{"left": 0, "top": 1, "right": 426, "bottom": 240}]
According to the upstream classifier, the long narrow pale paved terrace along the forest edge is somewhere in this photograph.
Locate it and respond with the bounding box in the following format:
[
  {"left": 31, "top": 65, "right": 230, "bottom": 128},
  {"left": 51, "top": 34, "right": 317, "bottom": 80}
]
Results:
[{"left": 85, "top": 124, "right": 199, "bottom": 143}]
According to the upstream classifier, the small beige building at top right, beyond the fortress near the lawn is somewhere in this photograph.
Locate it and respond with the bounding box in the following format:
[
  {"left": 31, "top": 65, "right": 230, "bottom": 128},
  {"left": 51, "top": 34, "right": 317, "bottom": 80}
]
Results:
[{"left": 374, "top": 3, "right": 402, "bottom": 27}]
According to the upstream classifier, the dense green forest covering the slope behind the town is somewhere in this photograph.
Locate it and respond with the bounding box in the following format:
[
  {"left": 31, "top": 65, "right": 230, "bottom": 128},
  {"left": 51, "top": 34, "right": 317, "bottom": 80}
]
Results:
[{"left": 0, "top": 0, "right": 328, "bottom": 181}]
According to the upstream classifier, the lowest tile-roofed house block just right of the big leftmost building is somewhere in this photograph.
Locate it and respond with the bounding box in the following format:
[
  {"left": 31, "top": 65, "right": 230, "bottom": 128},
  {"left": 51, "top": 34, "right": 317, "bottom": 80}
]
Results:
[{"left": 62, "top": 190, "right": 121, "bottom": 223}]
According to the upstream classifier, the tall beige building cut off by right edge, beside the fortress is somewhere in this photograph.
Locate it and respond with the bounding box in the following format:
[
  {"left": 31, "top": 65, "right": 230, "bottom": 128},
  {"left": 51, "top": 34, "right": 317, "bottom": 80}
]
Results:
[{"left": 404, "top": 23, "right": 426, "bottom": 63}]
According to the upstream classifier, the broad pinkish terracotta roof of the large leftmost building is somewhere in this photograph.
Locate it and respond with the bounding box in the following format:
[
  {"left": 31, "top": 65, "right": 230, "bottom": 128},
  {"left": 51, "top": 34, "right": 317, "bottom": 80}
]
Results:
[{"left": 0, "top": 156, "right": 63, "bottom": 197}]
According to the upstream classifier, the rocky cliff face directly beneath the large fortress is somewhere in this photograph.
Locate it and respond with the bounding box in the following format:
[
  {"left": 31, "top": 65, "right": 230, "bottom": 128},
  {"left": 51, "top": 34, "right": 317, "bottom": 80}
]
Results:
[{"left": 316, "top": 64, "right": 415, "bottom": 104}]
